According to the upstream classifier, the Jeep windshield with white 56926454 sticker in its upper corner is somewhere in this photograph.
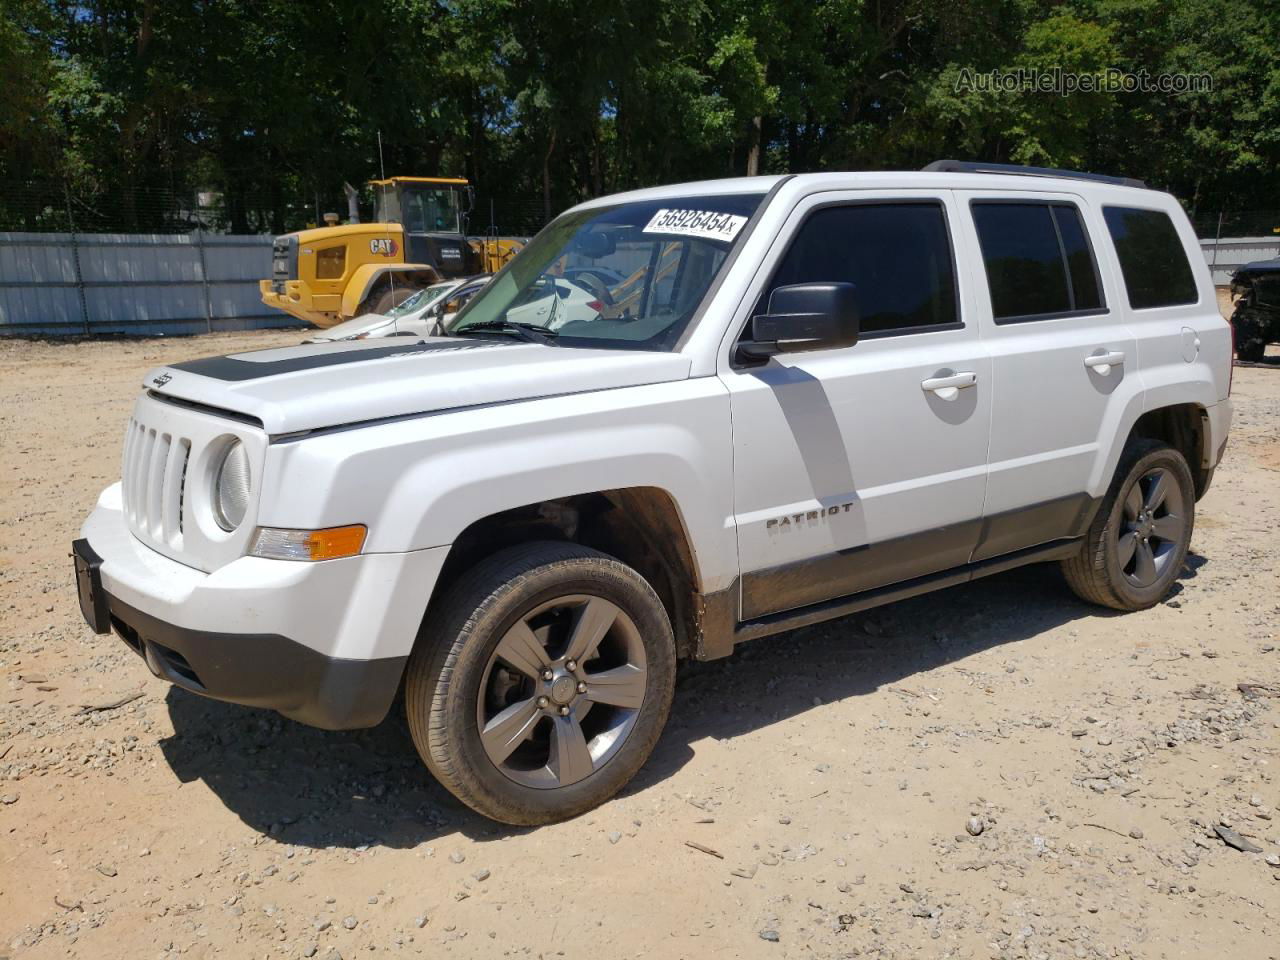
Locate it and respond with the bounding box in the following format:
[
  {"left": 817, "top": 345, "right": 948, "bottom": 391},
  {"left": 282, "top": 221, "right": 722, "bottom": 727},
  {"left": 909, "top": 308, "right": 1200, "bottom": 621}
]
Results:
[{"left": 448, "top": 193, "right": 764, "bottom": 351}]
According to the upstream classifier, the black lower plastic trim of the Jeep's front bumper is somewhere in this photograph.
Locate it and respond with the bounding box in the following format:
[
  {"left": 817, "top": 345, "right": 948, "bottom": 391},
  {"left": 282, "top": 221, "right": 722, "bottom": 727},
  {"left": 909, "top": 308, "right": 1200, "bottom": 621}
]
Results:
[{"left": 106, "top": 594, "right": 408, "bottom": 730}]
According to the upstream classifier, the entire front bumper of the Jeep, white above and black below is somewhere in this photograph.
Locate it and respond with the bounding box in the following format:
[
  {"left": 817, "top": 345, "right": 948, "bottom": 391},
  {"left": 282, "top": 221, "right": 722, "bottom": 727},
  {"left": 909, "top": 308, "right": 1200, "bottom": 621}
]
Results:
[{"left": 76, "top": 485, "right": 447, "bottom": 730}]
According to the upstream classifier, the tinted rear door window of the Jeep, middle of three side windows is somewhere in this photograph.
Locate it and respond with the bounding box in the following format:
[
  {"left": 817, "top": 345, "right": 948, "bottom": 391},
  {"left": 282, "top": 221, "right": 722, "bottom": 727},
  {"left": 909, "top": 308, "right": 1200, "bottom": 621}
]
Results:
[{"left": 972, "top": 201, "right": 1106, "bottom": 323}]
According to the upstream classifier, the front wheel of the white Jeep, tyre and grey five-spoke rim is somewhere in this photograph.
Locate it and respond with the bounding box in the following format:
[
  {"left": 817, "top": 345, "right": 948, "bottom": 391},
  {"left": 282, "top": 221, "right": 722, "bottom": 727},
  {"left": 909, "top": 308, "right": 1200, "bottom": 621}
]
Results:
[{"left": 406, "top": 541, "right": 676, "bottom": 824}]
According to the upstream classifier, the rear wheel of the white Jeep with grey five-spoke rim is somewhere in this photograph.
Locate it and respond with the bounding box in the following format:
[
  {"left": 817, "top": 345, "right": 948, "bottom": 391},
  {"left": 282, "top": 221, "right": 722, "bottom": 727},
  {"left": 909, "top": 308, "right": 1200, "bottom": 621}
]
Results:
[{"left": 1062, "top": 439, "right": 1196, "bottom": 611}]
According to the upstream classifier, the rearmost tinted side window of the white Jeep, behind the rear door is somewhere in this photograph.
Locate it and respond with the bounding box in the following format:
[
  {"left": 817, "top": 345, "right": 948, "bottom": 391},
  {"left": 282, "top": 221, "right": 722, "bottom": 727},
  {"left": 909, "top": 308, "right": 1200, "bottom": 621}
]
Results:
[{"left": 1102, "top": 206, "right": 1199, "bottom": 310}]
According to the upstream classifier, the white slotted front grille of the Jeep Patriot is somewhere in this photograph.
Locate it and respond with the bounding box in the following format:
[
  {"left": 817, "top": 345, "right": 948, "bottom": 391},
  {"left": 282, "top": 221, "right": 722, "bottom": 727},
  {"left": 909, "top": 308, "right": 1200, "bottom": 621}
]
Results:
[{"left": 123, "top": 419, "right": 191, "bottom": 549}]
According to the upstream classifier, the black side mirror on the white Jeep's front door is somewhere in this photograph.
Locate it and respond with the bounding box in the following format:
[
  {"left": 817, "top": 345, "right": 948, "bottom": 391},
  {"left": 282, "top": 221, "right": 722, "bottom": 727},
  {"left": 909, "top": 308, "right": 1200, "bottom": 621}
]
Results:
[{"left": 740, "top": 283, "right": 859, "bottom": 360}]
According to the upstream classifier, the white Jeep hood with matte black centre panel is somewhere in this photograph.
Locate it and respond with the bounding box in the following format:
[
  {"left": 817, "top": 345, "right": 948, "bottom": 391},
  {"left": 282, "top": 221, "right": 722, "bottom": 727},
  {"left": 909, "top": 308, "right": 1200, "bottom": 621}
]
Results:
[{"left": 143, "top": 337, "right": 690, "bottom": 435}]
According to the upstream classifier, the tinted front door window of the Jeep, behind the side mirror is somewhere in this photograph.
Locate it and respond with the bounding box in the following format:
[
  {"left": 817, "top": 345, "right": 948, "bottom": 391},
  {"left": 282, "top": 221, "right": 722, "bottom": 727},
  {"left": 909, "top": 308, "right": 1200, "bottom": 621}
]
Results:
[{"left": 756, "top": 202, "right": 960, "bottom": 333}]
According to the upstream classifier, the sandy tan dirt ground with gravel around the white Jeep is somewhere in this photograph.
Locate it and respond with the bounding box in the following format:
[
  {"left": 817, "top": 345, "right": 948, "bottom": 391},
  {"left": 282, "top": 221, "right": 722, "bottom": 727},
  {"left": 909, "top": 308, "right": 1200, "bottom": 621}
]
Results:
[{"left": 0, "top": 333, "right": 1280, "bottom": 960}]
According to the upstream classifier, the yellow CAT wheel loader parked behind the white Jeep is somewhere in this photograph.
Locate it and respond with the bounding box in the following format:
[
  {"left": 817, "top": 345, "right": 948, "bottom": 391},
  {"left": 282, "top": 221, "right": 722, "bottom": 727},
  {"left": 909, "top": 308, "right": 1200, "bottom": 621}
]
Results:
[{"left": 259, "top": 177, "right": 525, "bottom": 328}]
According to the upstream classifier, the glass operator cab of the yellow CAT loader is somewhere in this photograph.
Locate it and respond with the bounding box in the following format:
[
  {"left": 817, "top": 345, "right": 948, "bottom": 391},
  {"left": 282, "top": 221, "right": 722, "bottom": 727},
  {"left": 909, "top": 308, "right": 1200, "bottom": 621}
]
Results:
[{"left": 370, "top": 177, "right": 474, "bottom": 276}]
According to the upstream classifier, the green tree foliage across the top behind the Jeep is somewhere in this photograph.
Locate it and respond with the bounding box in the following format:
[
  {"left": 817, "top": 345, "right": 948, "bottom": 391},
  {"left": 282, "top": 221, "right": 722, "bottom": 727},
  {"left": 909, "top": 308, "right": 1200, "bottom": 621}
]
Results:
[{"left": 0, "top": 0, "right": 1280, "bottom": 230}]
